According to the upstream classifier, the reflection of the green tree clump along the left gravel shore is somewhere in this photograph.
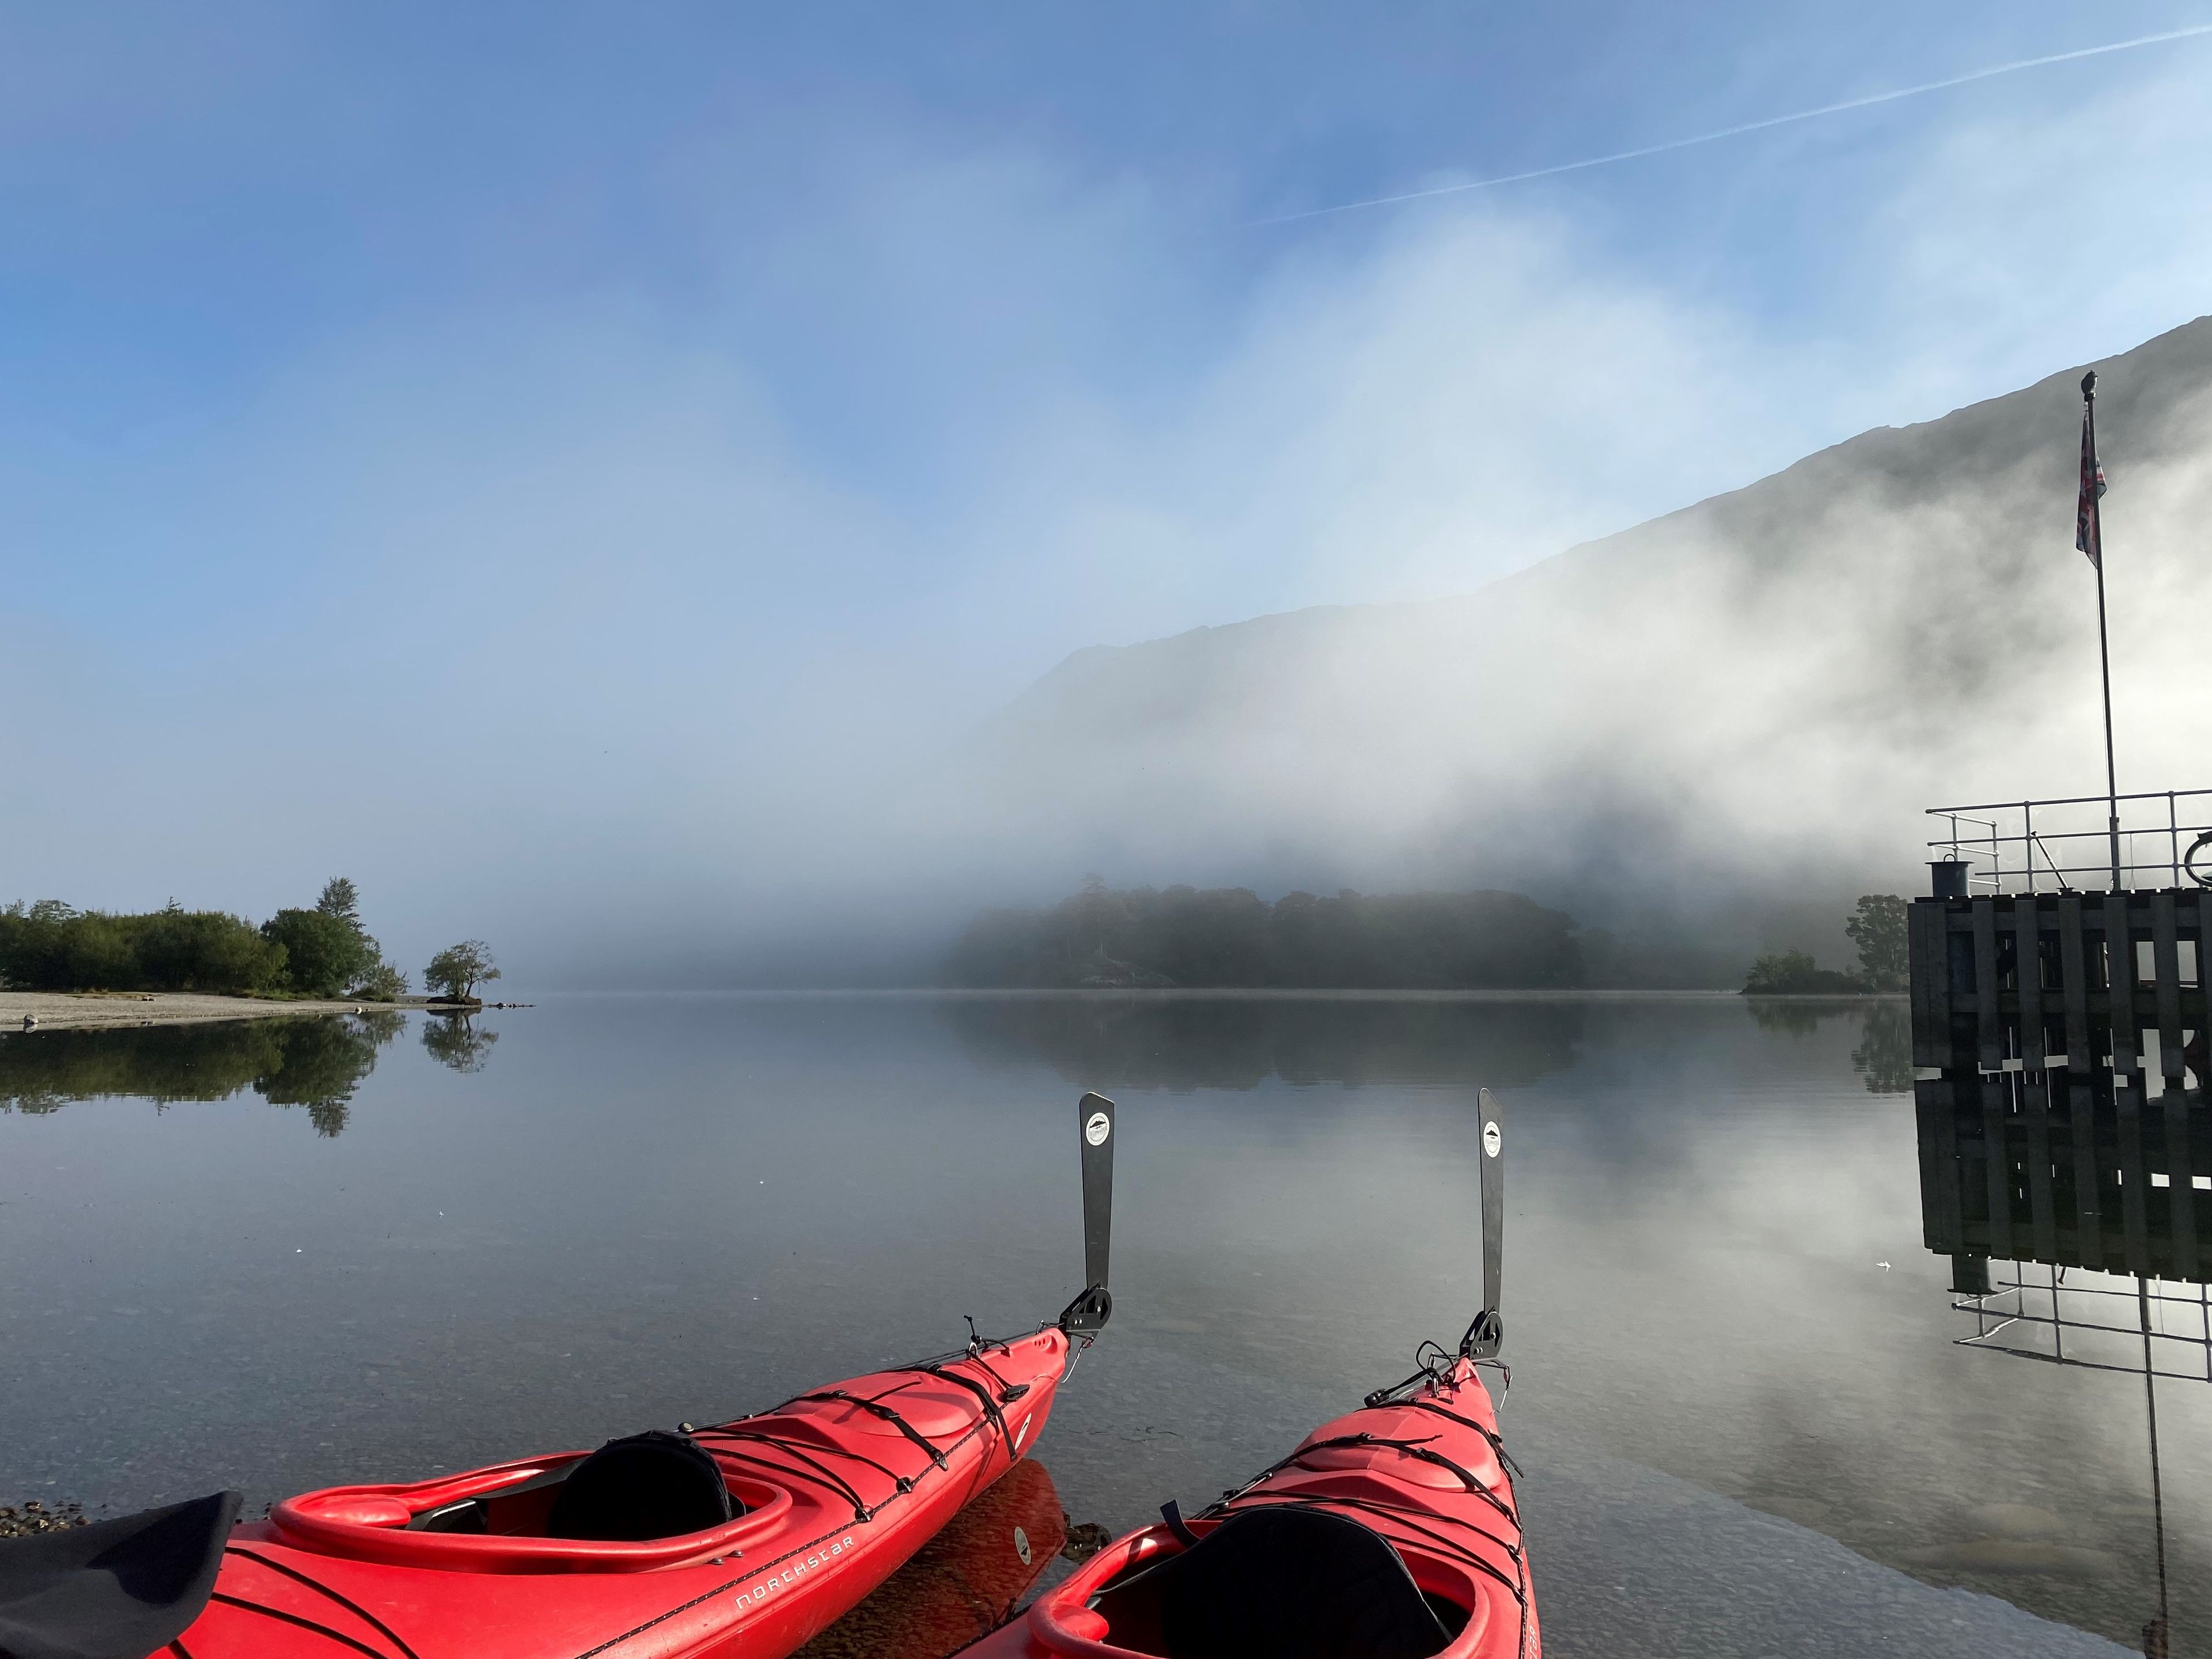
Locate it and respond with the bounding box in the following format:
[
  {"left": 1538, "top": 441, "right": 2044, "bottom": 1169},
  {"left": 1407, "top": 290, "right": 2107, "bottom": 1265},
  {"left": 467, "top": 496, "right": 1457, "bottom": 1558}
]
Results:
[{"left": 0, "top": 1009, "right": 407, "bottom": 1135}]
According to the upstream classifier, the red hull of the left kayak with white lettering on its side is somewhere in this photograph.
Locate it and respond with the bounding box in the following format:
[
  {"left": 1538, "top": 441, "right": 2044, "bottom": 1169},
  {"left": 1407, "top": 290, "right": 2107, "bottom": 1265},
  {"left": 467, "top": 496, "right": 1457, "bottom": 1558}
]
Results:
[{"left": 171, "top": 1325, "right": 1069, "bottom": 1659}]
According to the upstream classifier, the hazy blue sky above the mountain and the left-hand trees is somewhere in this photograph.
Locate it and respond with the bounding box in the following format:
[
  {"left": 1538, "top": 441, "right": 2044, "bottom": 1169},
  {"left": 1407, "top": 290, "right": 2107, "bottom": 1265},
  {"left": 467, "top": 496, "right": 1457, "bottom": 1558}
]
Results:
[{"left": 0, "top": 0, "right": 2212, "bottom": 978}]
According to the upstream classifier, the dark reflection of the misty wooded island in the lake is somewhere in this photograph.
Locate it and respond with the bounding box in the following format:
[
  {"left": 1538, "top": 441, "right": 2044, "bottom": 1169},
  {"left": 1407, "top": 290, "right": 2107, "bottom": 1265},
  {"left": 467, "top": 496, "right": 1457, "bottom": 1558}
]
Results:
[{"left": 940, "top": 993, "right": 1588, "bottom": 1093}]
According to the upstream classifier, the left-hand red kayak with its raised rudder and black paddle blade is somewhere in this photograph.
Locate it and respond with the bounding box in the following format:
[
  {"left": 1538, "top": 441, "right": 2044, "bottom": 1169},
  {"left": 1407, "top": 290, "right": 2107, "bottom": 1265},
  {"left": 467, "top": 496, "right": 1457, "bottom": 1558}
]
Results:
[{"left": 0, "top": 1095, "right": 1113, "bottom": 1659}]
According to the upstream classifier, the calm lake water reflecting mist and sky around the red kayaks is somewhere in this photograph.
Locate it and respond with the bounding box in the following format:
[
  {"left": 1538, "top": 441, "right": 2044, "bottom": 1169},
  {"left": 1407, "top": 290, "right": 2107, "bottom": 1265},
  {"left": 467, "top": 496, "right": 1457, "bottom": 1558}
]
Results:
[{"left": 0, "top": 995, "right": 2212, "bottom": 1659}]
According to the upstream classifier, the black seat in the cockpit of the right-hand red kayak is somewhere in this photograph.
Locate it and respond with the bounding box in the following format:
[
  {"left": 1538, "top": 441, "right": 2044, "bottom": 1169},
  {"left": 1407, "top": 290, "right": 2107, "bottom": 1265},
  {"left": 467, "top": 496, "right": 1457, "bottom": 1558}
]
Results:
[{"left": 1093, "top": 1506, "right": 1451, "bottom": 1659}]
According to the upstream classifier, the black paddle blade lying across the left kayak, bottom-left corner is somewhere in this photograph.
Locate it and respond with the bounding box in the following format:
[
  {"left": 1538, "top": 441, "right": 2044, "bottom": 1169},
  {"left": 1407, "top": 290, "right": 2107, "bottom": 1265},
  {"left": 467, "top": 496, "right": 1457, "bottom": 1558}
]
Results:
[{"left": 0, "top": 1491, "right": 239, "bottom": 1659}]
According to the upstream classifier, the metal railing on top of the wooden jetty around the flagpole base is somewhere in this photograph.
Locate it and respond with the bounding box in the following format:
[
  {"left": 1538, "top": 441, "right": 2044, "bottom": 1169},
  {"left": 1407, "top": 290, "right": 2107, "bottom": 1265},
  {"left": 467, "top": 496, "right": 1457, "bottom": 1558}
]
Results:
[{"left": 1929, "top": 790, "right": 2212, "bottom": 893}]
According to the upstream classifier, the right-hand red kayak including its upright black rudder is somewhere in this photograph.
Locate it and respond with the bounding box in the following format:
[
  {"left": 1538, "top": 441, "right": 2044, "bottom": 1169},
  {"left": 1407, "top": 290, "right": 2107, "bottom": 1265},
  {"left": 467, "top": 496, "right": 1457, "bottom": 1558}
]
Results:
[{"left": 967, "top": 1090, "right": 1541, "bottom": 1659}]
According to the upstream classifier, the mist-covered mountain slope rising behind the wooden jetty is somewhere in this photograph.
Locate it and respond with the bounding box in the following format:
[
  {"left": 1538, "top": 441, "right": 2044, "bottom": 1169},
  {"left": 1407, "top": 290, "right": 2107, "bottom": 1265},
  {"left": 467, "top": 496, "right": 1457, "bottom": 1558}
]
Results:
[{"left": 942, "top": 319, "right": 2212, "bottom": 982}]
